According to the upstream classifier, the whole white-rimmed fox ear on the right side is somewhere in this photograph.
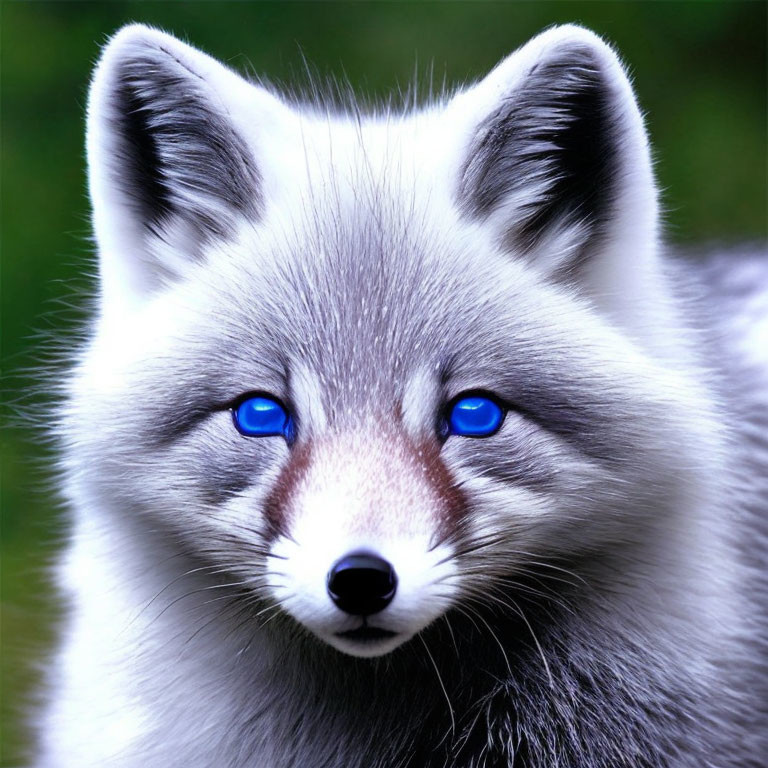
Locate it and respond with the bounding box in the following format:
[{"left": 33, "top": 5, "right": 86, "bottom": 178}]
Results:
[{"left": 451, "top": 26, "right": 657, "bottom": 278}]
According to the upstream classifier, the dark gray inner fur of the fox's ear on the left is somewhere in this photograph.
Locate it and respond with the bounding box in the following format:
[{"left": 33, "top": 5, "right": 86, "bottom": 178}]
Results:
[{"left": 107, "top": 30, "right": 260, "bottom": 237}]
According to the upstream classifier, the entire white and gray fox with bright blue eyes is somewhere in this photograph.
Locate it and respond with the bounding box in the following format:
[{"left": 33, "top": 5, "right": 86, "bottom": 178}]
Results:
[{"left": 38, "top": 25, "right": 768, "bottom": 768}]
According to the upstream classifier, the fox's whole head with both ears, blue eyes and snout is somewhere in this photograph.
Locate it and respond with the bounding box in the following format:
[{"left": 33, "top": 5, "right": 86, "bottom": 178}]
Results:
[{"left": 65, "top": 26, "right": 720, "bottom": 656}]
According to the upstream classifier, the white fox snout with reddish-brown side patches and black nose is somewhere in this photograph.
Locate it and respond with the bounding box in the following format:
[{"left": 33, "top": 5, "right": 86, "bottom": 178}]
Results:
[{"left": 267, "top": 430, "right": 458, "bottom": 656}]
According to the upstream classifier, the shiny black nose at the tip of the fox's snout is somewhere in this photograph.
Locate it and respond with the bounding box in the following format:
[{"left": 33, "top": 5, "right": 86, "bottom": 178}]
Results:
[{"left": 328, "top": 552, "right": 397, "bottom": 616}]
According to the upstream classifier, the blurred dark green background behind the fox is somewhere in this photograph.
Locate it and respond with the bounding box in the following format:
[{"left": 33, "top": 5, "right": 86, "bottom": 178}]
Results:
[{"left": 0, "top": 1, "right": 768, "bottom": 766}]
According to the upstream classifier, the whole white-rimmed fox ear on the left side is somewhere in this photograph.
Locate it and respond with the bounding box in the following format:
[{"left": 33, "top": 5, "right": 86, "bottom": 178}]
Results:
[{"left": 87, "top": 25, "right": 288, "bottom": 312}]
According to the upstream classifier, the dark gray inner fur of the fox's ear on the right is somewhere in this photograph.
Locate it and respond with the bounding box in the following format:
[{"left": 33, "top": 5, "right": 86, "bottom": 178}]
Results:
[{"left": 459, "top": 45, "right": 623, "bottom": 258}]
